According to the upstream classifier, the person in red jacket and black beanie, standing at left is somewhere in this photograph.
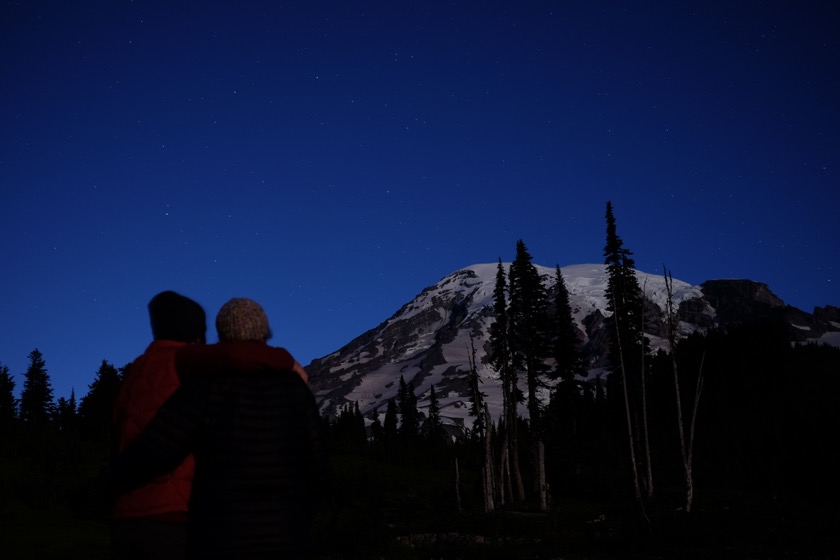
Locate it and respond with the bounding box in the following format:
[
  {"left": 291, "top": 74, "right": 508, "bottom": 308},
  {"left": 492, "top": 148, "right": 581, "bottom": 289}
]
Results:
[{"left": 111, "top": 291, "right": 207, "bottom": 559}]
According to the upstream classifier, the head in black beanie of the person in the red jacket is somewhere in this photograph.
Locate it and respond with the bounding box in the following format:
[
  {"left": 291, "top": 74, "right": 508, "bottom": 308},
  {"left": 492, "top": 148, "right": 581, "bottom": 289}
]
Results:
[{"left": 149, "top": 290, "right": 207, "bottom": 344}]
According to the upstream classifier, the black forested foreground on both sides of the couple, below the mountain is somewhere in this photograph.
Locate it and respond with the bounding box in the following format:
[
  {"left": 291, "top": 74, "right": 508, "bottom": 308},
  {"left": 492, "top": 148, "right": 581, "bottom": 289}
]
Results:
[{"left": 0, "top": 323, "right": 840, "bottom": 559}]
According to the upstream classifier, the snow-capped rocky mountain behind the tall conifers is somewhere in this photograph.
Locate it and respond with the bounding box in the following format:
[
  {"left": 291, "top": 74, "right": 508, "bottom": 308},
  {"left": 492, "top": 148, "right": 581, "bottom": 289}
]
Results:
[{"left": 307, "top": 264, "right": 840, "bottom": 434}]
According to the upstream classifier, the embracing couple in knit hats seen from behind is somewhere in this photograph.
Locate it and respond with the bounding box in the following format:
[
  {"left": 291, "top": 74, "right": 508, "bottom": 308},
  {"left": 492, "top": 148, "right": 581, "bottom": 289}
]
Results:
[{"left": 111, "top": 291, "right": 326, "bottom": 559}]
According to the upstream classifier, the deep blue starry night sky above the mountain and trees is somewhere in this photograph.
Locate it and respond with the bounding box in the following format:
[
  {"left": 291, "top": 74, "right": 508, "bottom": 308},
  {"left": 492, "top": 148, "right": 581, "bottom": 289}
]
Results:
[{"left": 0, "top": 0, "right": 840, "bottom": 398}]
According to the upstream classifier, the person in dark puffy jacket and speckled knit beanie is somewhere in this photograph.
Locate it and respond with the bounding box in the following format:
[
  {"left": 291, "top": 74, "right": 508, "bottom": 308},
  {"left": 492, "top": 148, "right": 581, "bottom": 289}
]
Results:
[{"left": 112, "top": 298, "right": 326, "bottom": 558}]
